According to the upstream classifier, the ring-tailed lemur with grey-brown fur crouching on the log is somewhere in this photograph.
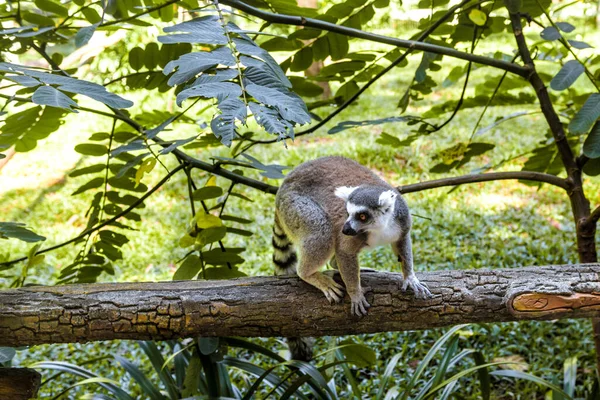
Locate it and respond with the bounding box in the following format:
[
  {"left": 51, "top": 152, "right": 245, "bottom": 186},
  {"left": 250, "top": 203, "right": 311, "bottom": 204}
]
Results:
[{"left": 273, "top": 157, "right": 431, "bottom": 359}]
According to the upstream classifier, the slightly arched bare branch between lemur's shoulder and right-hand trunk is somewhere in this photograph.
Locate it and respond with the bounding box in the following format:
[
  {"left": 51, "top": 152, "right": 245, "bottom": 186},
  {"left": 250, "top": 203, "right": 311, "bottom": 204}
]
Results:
[{"left": 397, "top": 171, "right": 569, "bottom": 194}]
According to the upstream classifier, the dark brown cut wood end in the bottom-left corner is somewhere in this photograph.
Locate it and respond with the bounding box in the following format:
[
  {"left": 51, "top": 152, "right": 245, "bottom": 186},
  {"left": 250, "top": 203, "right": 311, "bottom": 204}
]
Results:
[{"left": 0, "top": 368, "right": 42, "bottom": 400}]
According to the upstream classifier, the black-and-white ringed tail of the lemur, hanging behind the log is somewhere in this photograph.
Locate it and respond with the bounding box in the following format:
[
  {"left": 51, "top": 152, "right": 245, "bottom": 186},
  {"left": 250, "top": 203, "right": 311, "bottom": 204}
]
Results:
[{"left": 273, "top": 214, "right": 314, "bottom": 361}]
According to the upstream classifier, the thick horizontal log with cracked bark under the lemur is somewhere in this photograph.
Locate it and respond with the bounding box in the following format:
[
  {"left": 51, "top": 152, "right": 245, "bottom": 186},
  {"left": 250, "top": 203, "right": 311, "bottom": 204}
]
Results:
[{"left": 0, "top": 264, "right": 600, "bottom": 346}]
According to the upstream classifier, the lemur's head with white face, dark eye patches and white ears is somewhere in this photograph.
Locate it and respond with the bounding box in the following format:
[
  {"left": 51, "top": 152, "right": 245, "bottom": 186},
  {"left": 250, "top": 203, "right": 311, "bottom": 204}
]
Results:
[{"left": 335, "top": 186, "right": 398, "bottom": 236}]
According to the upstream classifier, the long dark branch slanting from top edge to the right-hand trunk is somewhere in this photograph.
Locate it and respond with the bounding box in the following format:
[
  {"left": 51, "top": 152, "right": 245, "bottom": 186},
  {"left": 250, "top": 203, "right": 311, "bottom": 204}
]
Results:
[{"left": 221, "top": 0, "right": 529, "bottom": 77}]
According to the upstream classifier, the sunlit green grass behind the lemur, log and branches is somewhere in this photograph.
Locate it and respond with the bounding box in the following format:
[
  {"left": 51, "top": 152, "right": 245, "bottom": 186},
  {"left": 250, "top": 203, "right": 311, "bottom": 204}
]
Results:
[{"left": 0, "top": 13, "right": 600, "bottom": 399}]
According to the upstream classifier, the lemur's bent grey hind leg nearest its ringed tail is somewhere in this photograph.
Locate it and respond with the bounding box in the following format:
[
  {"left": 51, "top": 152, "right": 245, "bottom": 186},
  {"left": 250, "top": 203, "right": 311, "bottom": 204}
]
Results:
[{"left": 277, "top": 193, "right": 344, "bottom": 303}]
